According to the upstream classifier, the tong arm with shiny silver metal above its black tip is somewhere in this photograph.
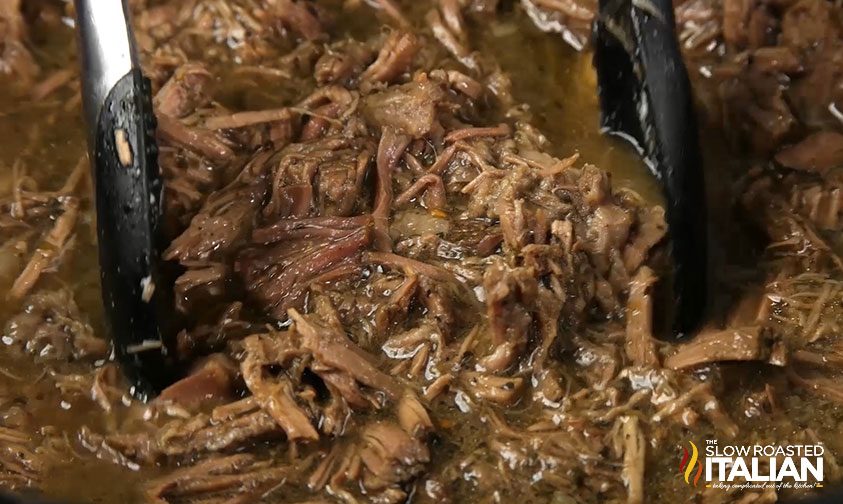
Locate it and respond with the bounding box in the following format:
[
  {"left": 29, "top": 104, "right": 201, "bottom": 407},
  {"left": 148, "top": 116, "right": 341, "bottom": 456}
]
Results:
[{"left": 74, "top": 0, "right": 174, "bottom": 399}]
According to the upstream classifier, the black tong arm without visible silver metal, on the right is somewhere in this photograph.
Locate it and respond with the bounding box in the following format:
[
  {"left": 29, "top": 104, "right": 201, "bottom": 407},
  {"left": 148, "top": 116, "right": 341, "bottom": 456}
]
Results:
[{"left": 593, "top": 0, "right": 707, "bottom": 337}]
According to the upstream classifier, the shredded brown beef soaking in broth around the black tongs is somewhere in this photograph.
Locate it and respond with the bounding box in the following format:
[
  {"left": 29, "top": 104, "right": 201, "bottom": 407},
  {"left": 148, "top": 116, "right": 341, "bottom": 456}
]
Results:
[{"left": 11, "top": 0, "right": 843, "bottom": 504}]
